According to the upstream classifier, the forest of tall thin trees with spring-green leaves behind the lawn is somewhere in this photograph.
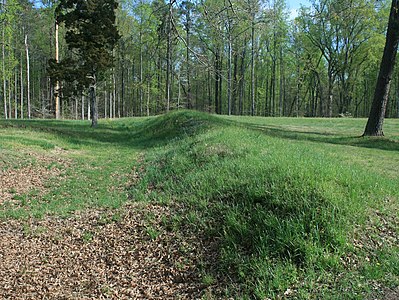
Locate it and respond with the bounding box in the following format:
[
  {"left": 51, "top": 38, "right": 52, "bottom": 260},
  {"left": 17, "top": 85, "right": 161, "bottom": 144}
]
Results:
[{"left": 0, "top": 0, "right": 399, "bottom": 119}]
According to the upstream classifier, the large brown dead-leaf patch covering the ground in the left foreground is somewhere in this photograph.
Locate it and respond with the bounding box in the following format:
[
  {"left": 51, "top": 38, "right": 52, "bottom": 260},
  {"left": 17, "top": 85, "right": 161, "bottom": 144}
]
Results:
[{"left": 0, "top": 205, "right": 223, "bottom": 299}]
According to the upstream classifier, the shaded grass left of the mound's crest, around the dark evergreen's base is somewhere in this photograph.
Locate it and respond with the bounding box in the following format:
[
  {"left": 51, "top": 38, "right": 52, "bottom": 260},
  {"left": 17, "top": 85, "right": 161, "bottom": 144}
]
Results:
[{"left": 0, "top": 111, "right": 217, "bottom": 150}]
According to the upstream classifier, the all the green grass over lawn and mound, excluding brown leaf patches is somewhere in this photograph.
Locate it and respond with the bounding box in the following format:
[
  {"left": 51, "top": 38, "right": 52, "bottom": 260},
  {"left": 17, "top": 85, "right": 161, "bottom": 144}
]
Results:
[{"left": 0, "top": 111, "right": 399, "bottom": 299}]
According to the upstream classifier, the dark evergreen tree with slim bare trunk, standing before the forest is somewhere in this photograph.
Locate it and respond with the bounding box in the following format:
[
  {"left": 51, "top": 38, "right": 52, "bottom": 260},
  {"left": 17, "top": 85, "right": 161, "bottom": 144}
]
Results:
[{"left": 50, "top": 0, "right": 120, "bottom": 127}]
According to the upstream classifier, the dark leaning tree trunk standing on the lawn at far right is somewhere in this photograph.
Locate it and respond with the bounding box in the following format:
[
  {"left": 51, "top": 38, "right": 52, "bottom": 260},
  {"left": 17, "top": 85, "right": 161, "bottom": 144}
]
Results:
[{"left": 363, "top": 0, "right": 399, "bottom": 136}]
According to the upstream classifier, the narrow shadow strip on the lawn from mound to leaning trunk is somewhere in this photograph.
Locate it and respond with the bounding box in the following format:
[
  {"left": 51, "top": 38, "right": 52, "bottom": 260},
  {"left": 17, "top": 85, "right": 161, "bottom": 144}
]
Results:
[{"left": 234, "top": 122, "right": 399, "bottom": 151}]
